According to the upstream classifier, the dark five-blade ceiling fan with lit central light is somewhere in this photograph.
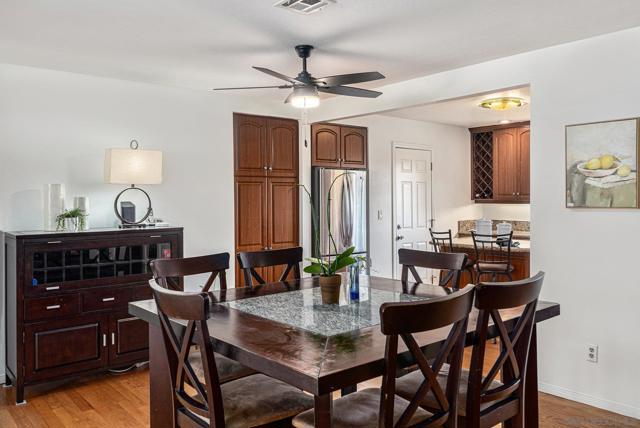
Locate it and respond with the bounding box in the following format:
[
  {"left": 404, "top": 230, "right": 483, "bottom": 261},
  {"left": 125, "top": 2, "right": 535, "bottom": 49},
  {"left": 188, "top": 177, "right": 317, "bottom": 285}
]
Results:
[{"left": 214, "top": 45, "right": 384, "bottom": 108}]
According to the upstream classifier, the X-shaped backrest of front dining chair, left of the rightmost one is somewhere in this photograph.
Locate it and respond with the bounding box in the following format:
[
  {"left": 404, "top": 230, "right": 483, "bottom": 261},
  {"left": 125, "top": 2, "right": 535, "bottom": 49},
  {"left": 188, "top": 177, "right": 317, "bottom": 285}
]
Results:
[{"left": 379, "top": 286, "right": 474, "bottom": 428}]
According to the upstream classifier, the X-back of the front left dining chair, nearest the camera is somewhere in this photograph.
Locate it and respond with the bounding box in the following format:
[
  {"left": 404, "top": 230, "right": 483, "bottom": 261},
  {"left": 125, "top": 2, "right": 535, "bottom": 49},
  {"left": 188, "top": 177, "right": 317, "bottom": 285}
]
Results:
[{"left": 150, "top": 281, "right": 224, "bottom": 427}]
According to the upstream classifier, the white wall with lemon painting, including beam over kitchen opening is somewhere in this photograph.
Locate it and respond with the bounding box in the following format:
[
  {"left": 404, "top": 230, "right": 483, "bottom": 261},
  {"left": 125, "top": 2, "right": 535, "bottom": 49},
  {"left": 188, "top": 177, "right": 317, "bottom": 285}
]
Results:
[{"left": 313, "top": 28, "right": 640, "bottom": 418}]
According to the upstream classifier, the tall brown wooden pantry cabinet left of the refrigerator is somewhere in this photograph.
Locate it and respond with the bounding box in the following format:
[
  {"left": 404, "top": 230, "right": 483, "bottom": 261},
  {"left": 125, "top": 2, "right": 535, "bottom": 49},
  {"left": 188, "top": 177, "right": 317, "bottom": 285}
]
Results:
[{"left": 233, "top": 113, "right": 300, "bottom": 286}]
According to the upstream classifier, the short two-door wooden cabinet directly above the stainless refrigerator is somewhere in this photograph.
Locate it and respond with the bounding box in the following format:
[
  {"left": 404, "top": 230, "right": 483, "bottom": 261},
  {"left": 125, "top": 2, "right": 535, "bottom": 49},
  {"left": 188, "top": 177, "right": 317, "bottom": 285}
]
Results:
[{"left": 311, "top": 123, "right": 367, "bottom": 169}]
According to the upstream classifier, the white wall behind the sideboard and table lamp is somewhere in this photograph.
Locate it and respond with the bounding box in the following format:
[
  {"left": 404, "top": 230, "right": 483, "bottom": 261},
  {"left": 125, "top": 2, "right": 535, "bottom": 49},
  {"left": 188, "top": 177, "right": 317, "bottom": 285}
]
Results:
[{"left": 0, "top": 64, "right": 309, "bottom": 382}]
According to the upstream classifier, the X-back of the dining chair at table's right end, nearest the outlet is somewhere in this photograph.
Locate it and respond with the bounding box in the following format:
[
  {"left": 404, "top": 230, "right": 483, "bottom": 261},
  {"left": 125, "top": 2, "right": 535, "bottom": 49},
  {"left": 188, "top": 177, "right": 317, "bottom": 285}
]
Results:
[{"left": 466, "top": 272, "right": 544, "bottom": 426}]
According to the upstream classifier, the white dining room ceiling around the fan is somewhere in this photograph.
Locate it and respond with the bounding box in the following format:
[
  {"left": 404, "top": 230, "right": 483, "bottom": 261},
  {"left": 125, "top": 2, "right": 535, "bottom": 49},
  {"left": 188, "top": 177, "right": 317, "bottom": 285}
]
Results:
[{"left": 0, "top": 0, "right": 640, "bottom": 99}]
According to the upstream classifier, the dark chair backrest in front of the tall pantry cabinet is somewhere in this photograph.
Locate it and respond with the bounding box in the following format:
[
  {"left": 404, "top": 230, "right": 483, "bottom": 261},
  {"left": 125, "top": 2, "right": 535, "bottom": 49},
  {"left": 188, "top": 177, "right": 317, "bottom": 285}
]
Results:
[{"left": 238, "top": 247, "right": 302, "bottom": 287}]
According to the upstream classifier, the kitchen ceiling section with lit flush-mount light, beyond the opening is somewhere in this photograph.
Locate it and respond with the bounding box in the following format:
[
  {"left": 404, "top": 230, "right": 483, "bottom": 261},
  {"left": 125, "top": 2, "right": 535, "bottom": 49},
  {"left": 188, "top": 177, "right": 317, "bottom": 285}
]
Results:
[{"left": 383, "top": 87, "right": 531, "bottom": 128}]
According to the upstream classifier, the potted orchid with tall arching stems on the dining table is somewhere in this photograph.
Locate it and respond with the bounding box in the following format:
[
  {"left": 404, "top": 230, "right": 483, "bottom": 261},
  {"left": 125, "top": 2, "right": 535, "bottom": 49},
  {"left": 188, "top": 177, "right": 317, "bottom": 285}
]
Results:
[{"left": 300, "top": 172, "right": 358, "bottom": 304}]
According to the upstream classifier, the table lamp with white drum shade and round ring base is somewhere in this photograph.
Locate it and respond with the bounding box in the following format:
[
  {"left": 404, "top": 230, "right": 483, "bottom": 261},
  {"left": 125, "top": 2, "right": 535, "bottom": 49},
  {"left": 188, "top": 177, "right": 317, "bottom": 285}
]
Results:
[{"left": 104, "top": 140, "right": 162, "bottom": 227}]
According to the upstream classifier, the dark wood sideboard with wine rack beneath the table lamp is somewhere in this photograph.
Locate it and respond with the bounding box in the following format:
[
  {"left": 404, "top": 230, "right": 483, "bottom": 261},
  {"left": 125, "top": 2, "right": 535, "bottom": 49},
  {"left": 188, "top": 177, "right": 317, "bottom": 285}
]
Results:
[{"left": 5, "top": 227, "right": 183, "bottom": 403}]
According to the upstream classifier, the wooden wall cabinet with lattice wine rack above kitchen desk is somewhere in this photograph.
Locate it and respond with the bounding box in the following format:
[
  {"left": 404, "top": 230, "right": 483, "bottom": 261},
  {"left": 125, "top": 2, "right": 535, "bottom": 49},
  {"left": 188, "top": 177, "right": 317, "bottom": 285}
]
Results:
[{"left": 469, "top": 123, "right": 530, "bottom": 203}]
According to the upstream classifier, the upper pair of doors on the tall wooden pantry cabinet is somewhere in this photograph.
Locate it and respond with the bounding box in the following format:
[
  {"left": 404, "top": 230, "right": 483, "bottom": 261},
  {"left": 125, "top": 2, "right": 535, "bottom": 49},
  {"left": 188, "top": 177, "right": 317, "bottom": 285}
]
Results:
[{"left": 233, "top": 113, "right": 298, "bottom": 177}]
